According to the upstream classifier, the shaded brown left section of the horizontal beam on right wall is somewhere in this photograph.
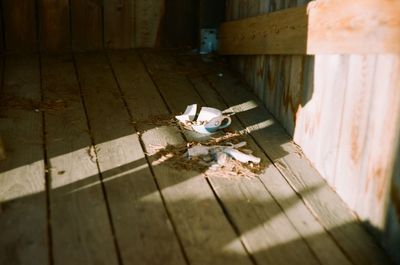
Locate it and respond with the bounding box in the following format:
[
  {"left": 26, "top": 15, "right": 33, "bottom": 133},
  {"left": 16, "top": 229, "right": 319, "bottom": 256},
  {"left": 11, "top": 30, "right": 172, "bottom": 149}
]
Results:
[{"left": 218, "top": 7, "right": 307, "bottom": 54}]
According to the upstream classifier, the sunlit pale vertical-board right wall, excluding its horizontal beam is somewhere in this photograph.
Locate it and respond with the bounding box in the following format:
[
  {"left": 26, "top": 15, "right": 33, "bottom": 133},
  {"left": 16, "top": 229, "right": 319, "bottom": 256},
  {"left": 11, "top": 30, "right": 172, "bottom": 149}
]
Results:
[{"left": 226, "top": 0, "right": 400, "bottom": 263}]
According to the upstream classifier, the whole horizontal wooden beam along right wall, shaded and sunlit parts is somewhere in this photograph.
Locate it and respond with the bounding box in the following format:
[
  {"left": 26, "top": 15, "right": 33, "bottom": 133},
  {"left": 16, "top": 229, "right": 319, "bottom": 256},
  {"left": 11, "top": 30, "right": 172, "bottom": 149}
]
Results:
[{"left": 219, "top": 0, "right": 400, "bottom": 54}]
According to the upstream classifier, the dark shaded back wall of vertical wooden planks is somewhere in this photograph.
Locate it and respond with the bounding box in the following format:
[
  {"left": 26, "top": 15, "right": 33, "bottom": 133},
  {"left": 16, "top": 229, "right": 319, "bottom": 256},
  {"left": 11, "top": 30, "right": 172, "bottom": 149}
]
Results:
[{"left": 0, "top": 0, "right": 203, "bottom": 51}]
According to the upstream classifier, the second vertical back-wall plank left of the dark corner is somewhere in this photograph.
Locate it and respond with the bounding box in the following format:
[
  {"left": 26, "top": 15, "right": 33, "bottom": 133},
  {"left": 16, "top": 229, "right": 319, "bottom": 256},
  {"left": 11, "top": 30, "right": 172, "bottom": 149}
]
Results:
[{"left": 104, "top": 0, "right": 135, "bottom": 49}]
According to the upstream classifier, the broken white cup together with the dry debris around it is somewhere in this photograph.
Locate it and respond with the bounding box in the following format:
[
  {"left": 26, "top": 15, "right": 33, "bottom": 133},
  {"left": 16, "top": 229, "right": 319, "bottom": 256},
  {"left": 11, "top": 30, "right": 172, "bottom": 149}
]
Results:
[{"left": 133, "top": 104, "right": 265, "bottom": 177}]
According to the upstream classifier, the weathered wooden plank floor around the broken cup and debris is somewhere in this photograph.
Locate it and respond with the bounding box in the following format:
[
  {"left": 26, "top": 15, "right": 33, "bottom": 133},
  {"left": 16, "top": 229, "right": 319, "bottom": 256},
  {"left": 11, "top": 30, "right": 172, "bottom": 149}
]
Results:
[{"left": 0, "top": 50, "right": 389, "bottom": 265}]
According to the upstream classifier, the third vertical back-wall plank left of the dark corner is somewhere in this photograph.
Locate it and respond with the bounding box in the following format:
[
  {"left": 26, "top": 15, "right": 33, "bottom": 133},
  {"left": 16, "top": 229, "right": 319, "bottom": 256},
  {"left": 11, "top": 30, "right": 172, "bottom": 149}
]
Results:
[{"left": 70, "top": 0, "right": 104, "bottom": 51}]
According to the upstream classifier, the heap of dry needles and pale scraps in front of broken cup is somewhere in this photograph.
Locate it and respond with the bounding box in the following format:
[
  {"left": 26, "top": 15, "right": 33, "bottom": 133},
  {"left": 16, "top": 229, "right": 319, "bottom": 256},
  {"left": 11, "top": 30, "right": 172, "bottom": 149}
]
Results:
[{"left": 154, "top": 133, "right": 265, "bottom": 177}]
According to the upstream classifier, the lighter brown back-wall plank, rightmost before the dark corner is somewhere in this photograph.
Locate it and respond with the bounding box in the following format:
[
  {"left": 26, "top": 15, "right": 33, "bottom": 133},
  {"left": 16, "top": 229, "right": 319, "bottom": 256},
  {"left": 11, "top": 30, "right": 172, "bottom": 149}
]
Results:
[{"left": 135, "top": 0, "right": 165, "bottom": 48}]
